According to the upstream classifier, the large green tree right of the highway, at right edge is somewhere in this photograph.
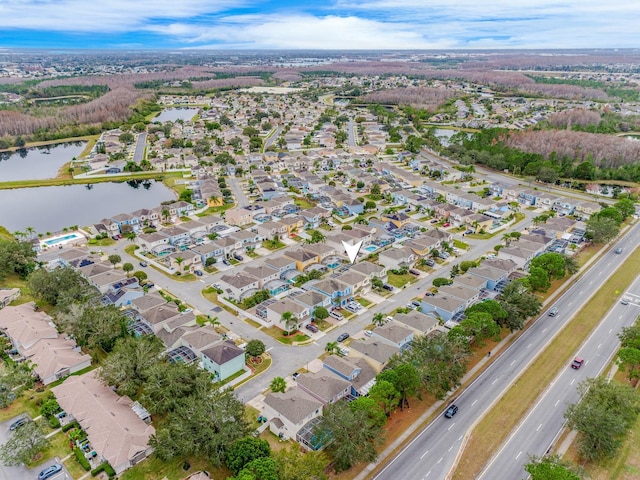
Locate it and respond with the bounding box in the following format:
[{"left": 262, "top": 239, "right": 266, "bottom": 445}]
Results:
[{"left": 564, "top": 377, "right": 640, "bottom": 462}]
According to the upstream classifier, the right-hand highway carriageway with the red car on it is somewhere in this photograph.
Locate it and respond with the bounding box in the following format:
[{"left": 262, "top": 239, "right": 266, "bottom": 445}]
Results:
[{"left": 478, "top": 229, "right": 640, "bottom": 480}]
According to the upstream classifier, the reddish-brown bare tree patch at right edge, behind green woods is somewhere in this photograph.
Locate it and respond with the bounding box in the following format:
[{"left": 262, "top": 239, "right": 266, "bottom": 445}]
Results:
[{"left": 504, "top": 130, "right": 640, "bottom": 168}]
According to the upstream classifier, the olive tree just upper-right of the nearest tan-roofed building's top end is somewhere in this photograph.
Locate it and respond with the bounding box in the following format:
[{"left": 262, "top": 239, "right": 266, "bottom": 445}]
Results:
[{"left": 98, "top": 335, "right": 165, "bottom": 397}]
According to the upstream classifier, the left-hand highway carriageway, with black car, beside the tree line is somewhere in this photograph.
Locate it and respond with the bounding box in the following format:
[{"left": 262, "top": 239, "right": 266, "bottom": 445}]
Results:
[{"left": 375, "top": 224, "right": 640, "bottom": 480}]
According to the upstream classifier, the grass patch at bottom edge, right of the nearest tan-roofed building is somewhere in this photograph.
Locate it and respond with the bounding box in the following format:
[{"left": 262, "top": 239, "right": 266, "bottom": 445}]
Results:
[{"left": 118, "top": 454, "right": 233, "bottom": 480}]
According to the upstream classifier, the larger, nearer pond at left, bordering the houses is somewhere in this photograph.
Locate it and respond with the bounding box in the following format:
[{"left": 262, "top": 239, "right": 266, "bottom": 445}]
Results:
[{"left": 0, "top": 180, "right": 176, "bottom": 233}]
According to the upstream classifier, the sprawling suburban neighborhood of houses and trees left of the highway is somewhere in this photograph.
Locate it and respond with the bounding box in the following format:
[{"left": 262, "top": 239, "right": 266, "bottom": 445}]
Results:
[{"left": 0, "top": 48, "right": 640, "bottom": 480}]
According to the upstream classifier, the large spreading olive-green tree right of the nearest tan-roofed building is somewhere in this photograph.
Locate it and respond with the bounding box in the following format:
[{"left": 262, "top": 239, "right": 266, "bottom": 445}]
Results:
[{"left": 149, "top": 390, "right": 248, "bottom": 466}]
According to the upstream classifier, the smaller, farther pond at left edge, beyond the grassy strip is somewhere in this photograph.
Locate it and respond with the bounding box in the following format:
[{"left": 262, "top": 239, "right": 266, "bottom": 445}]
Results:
[{"left": 0, "top": 142, "right": 86, "bottom": 182}]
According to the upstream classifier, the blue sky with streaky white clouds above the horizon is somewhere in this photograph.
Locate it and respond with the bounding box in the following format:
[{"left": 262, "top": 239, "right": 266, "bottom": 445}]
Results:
[{"left": 0, "top": 0, "right": 640, "bottom": 49}]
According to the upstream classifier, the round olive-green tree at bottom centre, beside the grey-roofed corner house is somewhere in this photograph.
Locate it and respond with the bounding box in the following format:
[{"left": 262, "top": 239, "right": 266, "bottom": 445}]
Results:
[{"left": 315, "top": 401, "right": 384, "bottom": 472}]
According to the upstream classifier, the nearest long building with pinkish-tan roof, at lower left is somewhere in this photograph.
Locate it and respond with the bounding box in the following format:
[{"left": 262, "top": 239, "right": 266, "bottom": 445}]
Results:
[{"left": 51, "top": 370, "right": 155, "bottom": 474}]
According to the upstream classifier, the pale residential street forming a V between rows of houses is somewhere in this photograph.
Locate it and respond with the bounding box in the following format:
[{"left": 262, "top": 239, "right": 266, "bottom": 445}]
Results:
[{"left": 102, "top": 213, "right": 534, "bottom": 402}]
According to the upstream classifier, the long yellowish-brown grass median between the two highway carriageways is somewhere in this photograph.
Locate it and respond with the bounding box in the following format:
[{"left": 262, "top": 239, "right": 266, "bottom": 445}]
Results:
[{"left": 453, "top": 249, "right": 640, "bottom": 480}]
